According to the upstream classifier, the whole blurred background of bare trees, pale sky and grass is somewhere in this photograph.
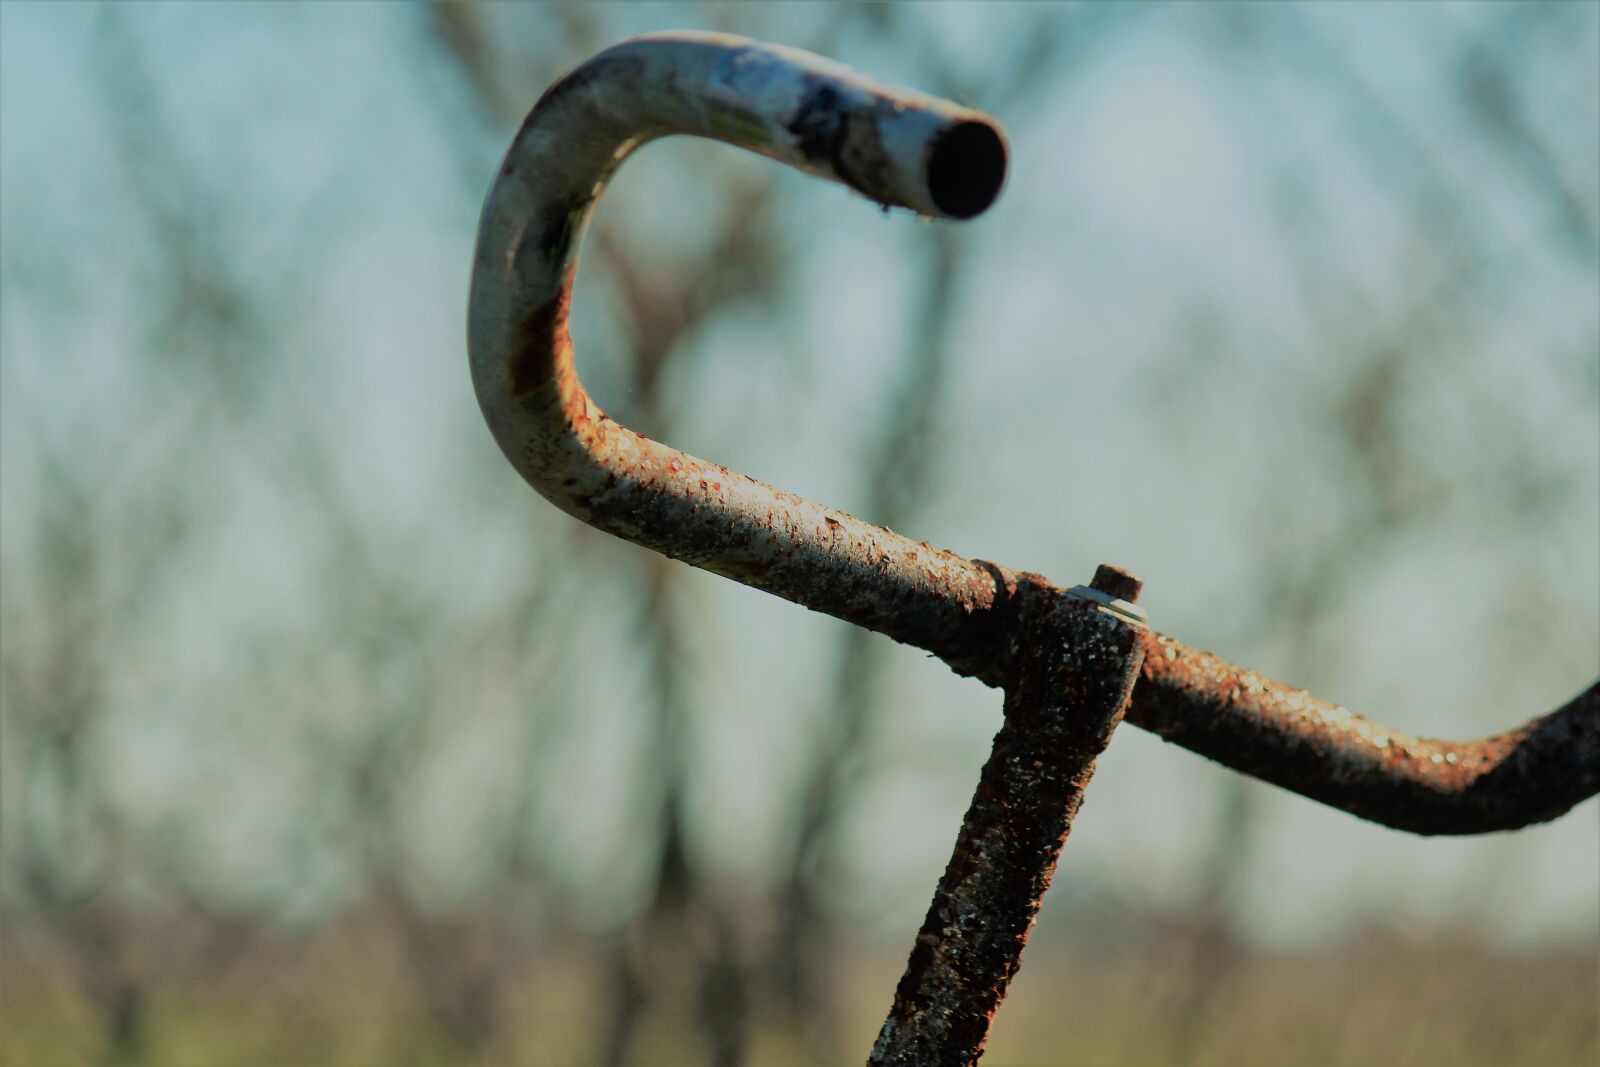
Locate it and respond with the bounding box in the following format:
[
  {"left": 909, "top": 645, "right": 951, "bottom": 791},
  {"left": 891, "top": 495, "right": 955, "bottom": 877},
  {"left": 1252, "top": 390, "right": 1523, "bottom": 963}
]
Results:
[{"left": 0, "top": 3, "right": 1600, "bottom": 1065}]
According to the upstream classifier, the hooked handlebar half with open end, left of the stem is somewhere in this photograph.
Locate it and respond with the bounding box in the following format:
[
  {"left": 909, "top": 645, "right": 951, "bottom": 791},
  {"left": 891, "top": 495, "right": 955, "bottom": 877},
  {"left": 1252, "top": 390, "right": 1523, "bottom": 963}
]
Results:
[{"left": 467, "top": 34, "right": 1006, "bottom": 673}]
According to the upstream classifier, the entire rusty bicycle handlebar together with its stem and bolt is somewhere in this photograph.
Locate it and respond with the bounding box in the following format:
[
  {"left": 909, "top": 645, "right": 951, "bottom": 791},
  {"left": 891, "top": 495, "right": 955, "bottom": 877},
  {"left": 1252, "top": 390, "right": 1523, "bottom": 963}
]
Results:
[{"left": 467, "top": 34, "right": 1600, "bottom": 1064}]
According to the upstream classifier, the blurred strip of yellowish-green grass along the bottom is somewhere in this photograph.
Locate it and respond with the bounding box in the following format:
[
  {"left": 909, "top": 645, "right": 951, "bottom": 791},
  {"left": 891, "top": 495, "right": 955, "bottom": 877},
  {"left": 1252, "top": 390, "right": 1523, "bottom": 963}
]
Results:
[{"left": 0, "top": 923, "right": 1600, "bottom": 1067}]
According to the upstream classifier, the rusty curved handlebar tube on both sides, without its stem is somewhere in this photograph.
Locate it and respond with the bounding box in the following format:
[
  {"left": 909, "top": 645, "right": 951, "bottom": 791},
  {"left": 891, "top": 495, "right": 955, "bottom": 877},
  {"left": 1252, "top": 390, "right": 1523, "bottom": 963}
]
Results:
[{"left": 467, "top": 34, "right": 1600, "bottom": 833}]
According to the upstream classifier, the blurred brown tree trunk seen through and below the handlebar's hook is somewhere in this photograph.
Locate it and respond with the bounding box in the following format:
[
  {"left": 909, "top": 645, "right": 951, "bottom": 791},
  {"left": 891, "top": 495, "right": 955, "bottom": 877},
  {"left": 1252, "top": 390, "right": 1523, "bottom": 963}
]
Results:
[{"left": 432, "top": 5, "right": 776, "bottom": 1064}]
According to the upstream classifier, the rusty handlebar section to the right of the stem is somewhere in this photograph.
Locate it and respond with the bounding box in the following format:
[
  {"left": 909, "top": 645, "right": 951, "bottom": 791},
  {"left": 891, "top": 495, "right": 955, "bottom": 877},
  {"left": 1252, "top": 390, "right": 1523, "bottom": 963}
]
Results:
[{"left": 1128, "top": 635, "right": 1600, "bottom": 833}]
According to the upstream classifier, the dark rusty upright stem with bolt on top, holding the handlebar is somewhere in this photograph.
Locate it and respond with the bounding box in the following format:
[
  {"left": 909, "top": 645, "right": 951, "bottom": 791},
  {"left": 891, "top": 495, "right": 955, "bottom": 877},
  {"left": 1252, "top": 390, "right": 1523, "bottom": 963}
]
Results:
[{"left": 867, "top": 566, "right": 1144, "bottom": 1067}]
